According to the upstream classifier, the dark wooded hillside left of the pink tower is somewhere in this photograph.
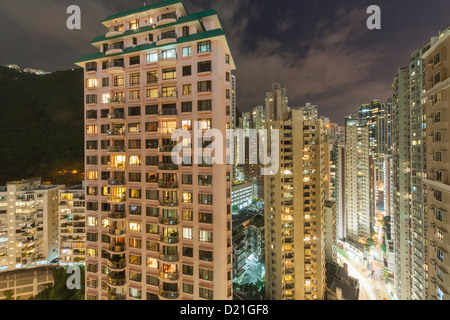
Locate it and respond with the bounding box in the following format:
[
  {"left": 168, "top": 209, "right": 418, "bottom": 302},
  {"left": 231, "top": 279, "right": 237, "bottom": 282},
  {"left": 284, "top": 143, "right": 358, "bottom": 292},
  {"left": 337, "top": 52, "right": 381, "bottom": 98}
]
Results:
[{"left": 0, "top": 67, "right": 84, "bottom": 185}]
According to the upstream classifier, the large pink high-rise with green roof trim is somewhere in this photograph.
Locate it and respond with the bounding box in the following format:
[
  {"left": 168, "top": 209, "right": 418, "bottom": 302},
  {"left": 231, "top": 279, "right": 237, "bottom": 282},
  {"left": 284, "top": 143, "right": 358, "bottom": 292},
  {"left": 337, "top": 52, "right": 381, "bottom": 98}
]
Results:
[{"left": 76, "top": 0, "right": 235, "bottom": 300}]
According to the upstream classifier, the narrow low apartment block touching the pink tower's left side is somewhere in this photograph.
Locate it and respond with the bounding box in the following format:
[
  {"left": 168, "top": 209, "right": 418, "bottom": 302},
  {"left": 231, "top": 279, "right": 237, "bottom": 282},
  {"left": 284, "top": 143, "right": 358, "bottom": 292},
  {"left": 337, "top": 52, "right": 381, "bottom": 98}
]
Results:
[{"left": 59, "top": 185, "right": 86, "bottom": 266}]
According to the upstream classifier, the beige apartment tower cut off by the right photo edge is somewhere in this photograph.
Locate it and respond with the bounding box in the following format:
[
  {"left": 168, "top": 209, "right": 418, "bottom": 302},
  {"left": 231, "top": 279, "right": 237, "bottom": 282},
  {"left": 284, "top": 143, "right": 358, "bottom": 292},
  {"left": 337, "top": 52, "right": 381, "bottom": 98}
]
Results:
[{"left": 422, "top": 28, "right": 450, "bottom": 300}]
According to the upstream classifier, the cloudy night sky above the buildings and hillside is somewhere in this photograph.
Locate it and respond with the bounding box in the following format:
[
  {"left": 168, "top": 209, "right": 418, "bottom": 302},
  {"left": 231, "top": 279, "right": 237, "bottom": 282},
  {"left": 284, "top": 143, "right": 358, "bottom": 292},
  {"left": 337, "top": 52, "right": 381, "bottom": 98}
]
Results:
[{"left": 0, "top": 0, "right": 450, "bottom": 124}]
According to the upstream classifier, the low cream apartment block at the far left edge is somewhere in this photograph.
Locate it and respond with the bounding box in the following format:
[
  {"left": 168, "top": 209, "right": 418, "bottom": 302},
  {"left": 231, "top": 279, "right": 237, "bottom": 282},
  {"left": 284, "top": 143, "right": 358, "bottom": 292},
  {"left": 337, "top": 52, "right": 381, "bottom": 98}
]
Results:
[{"left": 0, "top": 178, "right": 63, "bottom": 271}]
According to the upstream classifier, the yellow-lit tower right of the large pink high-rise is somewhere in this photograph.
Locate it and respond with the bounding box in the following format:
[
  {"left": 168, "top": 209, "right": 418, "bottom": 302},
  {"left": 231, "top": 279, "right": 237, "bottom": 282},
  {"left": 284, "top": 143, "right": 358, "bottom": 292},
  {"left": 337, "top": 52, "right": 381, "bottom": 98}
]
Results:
[{"left": 264, "top": 110, "right": 325, "bottom": 300}]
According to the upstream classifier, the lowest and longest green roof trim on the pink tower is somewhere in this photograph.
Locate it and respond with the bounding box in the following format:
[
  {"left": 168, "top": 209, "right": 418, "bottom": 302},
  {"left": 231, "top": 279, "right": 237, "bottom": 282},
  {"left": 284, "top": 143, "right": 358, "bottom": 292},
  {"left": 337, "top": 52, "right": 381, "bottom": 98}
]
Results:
[{"left": 74, "top": 29, "right": 226, "bottom": 64}]
